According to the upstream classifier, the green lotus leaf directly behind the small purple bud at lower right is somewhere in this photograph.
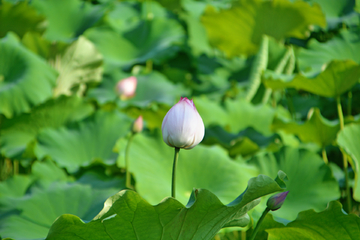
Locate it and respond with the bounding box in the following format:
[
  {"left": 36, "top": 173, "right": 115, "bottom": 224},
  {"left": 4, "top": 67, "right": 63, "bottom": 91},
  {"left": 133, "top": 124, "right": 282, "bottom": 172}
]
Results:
[{"left": 249, "top": 147, "right": 340, "bottom": 220}]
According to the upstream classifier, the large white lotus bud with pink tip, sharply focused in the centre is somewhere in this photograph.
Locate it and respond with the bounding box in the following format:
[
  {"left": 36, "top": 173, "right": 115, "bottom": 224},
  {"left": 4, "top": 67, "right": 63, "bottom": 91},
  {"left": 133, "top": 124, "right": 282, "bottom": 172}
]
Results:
[{"left": 161, "top": 97, "right": 205, "bottom": 149}]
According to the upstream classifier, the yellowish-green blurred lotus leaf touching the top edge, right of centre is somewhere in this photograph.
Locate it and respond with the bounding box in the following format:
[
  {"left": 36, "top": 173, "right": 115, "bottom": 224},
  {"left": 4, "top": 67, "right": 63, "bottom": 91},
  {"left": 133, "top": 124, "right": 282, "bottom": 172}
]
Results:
[{"left": 201, "top": 0, "right": 326, "bottom": 57}]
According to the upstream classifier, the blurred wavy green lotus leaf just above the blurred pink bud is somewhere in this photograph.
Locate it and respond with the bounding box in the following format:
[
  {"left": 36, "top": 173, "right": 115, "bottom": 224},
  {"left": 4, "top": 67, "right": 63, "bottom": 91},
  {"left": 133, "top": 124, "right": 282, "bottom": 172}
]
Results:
[{"left": 85, "top": 18, "right": 185, "bottom": 68}]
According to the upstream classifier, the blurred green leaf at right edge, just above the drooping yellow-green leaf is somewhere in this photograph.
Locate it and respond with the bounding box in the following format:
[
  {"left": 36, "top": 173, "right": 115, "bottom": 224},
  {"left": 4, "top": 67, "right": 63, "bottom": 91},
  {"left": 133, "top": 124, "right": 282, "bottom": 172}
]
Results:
[{"left": 297, "top": 29, "right": 360, "bottom": 72}]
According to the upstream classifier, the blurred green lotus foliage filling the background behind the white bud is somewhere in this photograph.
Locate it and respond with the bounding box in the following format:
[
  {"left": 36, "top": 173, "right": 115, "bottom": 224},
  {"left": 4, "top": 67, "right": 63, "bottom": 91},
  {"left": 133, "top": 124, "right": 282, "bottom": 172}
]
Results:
[{"left": 0, "top": 0, "right": 360, "bottom": 240}]
